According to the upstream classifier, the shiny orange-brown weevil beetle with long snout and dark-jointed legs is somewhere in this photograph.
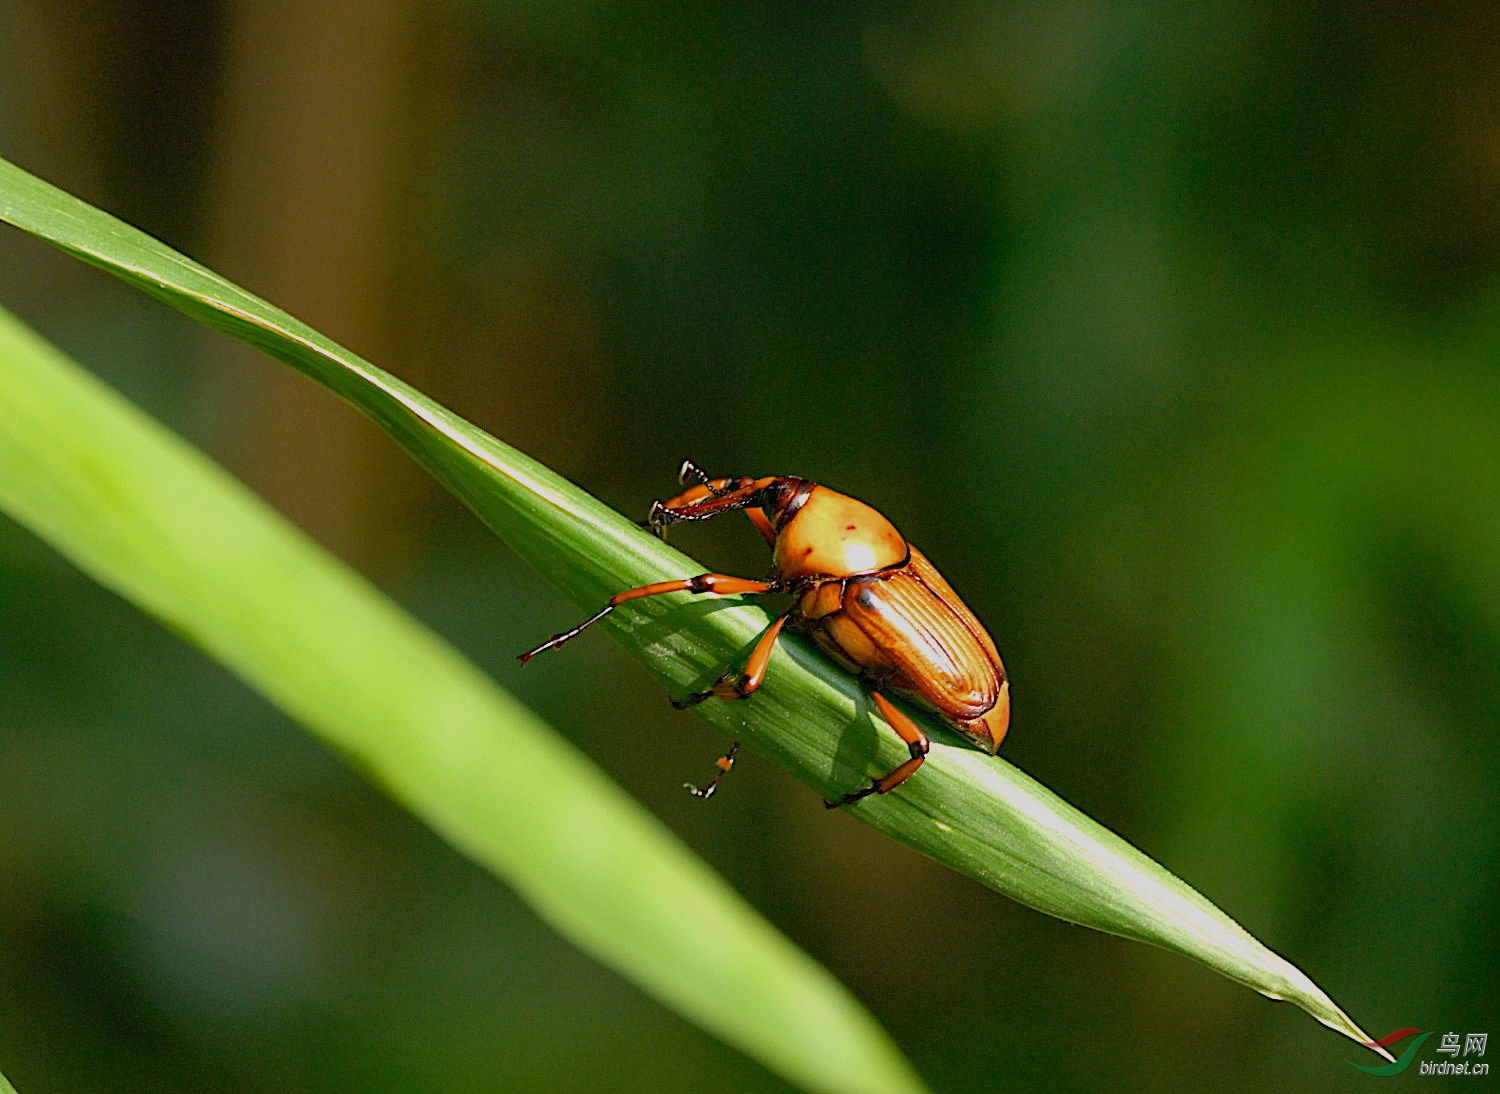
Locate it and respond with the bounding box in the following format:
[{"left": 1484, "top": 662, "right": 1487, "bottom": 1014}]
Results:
[{"left": 518, "top": 461, "right": 1011, "bottom": 809}]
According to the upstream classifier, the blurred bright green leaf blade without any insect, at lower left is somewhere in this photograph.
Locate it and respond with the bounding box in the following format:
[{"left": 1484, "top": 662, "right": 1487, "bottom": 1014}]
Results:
[{"left": 0, "top": 311, "right": 921, "bottom": 1091}]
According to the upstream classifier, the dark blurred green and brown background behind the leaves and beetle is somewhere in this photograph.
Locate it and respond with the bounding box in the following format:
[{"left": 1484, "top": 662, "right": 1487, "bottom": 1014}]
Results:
[{"left": 0, "top": 0, "right": 1500, "bottom": 1092}]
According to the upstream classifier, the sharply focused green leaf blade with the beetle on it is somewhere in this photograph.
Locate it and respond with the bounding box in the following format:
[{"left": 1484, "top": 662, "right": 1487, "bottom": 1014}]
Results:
[{"left": 0, "top": 164, "right": 1385, "bottom": 1055}]
